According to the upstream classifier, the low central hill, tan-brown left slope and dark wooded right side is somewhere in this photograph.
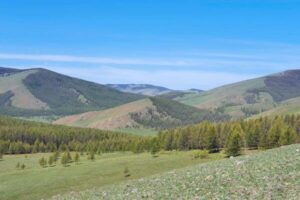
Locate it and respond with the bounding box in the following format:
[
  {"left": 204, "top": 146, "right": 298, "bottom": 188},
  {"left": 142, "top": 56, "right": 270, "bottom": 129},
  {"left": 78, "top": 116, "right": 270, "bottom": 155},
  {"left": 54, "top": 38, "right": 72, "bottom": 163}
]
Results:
[{"left": 54, "top": 97, "right": 227, "bottom": 133}]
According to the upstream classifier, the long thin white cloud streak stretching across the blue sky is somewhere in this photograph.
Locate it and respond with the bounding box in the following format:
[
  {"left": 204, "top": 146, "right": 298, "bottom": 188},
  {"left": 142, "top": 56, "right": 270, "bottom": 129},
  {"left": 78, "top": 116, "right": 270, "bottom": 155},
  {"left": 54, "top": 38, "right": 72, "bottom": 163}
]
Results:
[{"left": 0, "top": 53, "right": 292, "bottom": 68}]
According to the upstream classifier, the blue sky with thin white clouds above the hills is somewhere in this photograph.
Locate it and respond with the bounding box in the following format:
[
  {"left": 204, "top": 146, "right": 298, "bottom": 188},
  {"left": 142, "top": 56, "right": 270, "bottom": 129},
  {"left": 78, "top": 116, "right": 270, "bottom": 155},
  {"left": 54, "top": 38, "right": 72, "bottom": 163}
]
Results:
[{"left": 0, "top": 0, "right": 300, "bottom": 90}]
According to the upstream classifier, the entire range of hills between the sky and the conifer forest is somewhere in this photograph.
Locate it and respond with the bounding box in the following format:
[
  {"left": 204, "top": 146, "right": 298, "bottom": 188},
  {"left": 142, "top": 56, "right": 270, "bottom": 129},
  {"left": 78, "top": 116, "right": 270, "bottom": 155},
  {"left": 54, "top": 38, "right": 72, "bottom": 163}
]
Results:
[{"left": 0, "top": 68, "right": 300, "bottom": 132}]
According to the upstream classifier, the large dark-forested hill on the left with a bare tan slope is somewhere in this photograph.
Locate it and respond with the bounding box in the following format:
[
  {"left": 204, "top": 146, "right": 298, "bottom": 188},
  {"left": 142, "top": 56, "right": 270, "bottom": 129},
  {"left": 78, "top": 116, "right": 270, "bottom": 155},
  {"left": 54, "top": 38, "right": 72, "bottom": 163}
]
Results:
[{"left": 0, "top": 68, "right": 143, "bottom": 116}]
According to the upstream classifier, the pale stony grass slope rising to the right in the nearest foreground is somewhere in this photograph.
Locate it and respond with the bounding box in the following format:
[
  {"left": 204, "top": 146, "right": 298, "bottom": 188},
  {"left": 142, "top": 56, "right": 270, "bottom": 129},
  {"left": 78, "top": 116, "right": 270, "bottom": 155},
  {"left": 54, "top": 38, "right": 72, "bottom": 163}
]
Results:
[{"left": 53, "top": 144, "right": 300, "bottom": 200}]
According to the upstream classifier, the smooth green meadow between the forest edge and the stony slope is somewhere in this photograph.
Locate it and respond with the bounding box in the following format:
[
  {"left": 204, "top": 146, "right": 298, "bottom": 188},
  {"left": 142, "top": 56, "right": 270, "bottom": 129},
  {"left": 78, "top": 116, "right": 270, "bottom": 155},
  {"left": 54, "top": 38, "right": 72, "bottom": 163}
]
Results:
[{"left": 0, "top": 152, "right": 224, "bottom": 200}]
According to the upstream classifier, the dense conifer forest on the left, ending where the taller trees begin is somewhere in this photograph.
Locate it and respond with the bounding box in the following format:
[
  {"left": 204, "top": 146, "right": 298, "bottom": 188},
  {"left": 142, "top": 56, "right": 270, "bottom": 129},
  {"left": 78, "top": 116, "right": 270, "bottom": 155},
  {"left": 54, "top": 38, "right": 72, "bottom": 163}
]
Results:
[{"left": 0, "top": 117, "right": 152, "bottom": 154}]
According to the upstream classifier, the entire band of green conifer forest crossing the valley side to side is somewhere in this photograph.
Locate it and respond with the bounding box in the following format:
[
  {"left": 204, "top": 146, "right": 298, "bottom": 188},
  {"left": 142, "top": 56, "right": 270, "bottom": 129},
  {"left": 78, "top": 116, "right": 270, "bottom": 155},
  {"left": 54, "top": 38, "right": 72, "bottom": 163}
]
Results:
[{"left": 0, "top": 115, "right": 300, "bottom": 156}]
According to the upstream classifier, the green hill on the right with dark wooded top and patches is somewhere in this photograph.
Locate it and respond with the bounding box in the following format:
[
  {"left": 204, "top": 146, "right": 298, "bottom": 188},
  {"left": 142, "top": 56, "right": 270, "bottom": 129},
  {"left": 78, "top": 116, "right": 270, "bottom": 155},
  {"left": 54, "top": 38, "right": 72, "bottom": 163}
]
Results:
[{"left": 175, "top": 70, "right": 300, "bottom": 118}]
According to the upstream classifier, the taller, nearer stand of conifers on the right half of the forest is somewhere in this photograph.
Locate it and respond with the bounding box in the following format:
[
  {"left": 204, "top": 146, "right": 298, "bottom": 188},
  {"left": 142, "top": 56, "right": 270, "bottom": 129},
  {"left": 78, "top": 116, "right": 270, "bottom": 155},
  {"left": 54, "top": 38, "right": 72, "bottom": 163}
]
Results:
[{"left": 158, "top": 115, "right": 300, "bottom": 155}]
